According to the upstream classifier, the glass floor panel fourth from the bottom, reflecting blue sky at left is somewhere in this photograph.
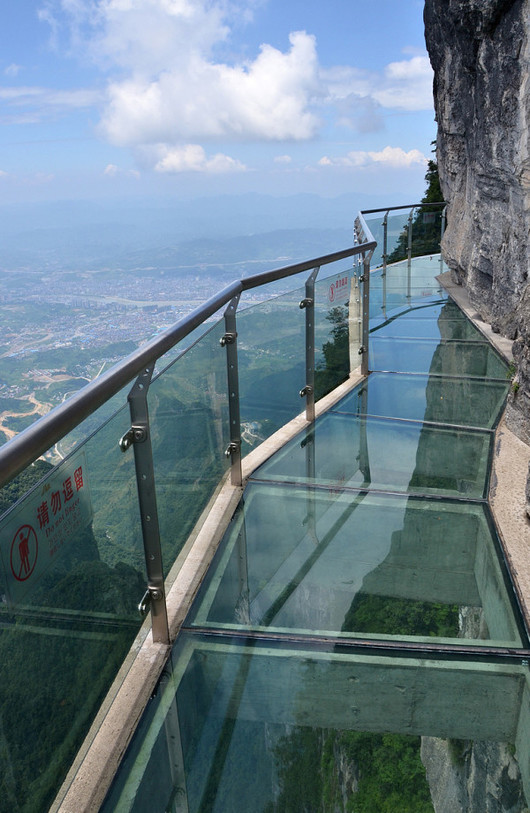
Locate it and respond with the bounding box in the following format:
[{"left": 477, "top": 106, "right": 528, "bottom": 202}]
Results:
[{"left": 332, "top": 373, "right": 510, "bottom": 429}]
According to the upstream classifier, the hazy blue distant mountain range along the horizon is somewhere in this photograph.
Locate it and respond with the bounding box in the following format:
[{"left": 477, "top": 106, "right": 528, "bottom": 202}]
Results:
[{"left": 0, "top": 193, "right": 388, "bottom": 270}]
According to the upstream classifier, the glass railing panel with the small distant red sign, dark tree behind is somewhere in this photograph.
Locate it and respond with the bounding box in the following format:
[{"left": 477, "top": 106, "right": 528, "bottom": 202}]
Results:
[{"left": 315, "top": 261, "right": 362, "bottom": 400}]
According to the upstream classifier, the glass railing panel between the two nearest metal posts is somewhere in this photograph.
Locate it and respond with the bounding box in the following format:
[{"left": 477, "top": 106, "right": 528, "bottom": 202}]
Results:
[{"left": 149, "top": 321, "right": 230, "bottom": 575}]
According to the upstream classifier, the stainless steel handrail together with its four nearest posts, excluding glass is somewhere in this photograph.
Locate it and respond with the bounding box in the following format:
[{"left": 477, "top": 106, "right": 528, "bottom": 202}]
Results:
[{"left": 0, "top": 215, "right": 377, "bottom": 644}]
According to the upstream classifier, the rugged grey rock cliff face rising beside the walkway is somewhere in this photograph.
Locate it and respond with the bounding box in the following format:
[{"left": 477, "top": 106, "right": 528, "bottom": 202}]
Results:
[{"left": 424, "top": 0, "right": 530, "bottom": 442}]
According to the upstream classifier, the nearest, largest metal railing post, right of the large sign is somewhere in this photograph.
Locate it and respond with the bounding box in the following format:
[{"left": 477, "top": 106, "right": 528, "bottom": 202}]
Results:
[{"left": 120, "top": 363, "right": 169, "bottom": 644}]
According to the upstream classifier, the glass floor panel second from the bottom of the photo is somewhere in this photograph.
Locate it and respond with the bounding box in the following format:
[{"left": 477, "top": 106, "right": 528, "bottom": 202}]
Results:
[{"left": 191, "top": 484, "right": 522, "bottom": 646}]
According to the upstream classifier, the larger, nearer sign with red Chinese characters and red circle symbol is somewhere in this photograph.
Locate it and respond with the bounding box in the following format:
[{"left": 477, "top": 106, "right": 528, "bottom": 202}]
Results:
[{"left": 0, "top": 452, "right": 92, "bottom": 607}]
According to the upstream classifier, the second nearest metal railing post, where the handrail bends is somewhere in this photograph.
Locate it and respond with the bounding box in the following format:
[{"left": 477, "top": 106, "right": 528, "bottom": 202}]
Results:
[{"left": 221, "top": 294, "right": 243, "bottom": 486}]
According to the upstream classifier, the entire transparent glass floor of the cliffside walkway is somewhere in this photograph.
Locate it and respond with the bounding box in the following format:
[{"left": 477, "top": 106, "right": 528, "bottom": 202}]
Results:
[{"left": 103, "top": 257, "right": 530, "bottom": 813}]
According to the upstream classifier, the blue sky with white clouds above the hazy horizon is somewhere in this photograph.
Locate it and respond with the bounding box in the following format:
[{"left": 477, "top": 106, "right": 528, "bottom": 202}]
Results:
[{"left": 0, "top": 0, "right": 436, "bottom": 205}]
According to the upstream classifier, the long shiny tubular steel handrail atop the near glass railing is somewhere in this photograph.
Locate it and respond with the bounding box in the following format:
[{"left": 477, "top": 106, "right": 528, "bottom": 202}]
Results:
[{"left": 0, "top": 238, "right": 377, "bottom": 488}]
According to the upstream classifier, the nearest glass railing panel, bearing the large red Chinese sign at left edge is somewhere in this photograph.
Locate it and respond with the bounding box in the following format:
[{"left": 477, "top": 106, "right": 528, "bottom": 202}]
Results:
[{"left": 0, "top": 407, "right": 146, "bottom": 811}]
